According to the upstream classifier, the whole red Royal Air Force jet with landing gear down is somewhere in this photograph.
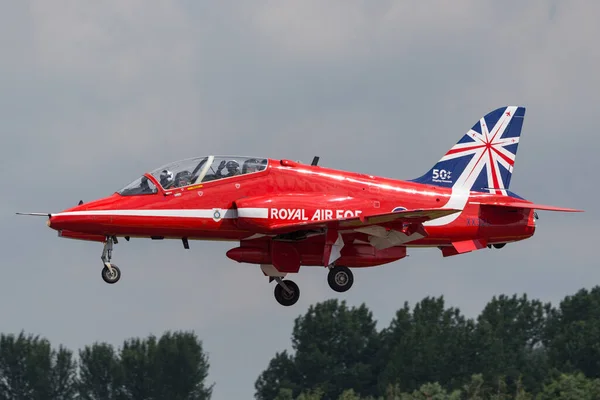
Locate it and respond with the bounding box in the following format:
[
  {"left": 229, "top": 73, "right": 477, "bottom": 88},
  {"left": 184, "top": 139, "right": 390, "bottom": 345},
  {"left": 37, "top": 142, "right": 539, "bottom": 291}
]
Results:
[{"left": 19, "top": 106, "right": 581, "bottom": 306}]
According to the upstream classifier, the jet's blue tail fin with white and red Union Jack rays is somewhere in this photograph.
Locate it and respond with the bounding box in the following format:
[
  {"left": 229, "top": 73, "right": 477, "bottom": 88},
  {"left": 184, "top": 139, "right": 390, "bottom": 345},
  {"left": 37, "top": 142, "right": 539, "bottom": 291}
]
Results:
[{"left": 412, "top": 106, "right": 525, "bottom": 195}]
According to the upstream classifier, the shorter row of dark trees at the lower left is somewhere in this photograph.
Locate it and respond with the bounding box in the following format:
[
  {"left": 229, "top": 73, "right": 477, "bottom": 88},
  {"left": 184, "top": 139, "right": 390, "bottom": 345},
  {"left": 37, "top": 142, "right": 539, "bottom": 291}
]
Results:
[{"left": 0, "top": 332, "right": 212, "bottom": 400}]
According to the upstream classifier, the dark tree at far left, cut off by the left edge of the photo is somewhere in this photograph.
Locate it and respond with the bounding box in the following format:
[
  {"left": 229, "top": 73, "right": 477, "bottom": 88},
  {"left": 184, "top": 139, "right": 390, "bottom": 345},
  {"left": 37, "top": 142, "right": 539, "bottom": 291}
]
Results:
[{"left": 0, "top": 332, "right": 76, "bottom": 400}]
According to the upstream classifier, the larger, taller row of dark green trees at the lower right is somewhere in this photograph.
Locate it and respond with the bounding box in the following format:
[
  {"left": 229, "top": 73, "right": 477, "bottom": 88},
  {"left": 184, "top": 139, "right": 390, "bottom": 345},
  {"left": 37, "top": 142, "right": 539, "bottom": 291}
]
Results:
[{"left": 255, "top": 286, "right": 600, "bottom": 400}]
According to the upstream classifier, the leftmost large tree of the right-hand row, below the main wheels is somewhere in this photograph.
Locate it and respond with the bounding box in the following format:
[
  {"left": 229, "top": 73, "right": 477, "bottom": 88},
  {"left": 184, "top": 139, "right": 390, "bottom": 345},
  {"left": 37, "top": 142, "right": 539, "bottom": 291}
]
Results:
[{"left": 255, "top": 300, "right": 379, "bottom": 400}]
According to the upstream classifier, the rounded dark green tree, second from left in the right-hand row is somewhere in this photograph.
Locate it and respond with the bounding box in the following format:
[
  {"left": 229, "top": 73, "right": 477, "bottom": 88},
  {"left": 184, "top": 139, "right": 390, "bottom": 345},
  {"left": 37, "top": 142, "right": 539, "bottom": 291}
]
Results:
[{"left": 379, "top": 296, "right": 474, "bottom": 392}]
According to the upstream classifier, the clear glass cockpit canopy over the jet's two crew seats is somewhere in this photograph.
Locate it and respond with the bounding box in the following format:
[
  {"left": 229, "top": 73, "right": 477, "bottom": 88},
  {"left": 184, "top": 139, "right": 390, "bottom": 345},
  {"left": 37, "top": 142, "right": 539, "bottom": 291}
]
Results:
[{"left": 118, "top": 156, "right": 268, "bottom": 196}]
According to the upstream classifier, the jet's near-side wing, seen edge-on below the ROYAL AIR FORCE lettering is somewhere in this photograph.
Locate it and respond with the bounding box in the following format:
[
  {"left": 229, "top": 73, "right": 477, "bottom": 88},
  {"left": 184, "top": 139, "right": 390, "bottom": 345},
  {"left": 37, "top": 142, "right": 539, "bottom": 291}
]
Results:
[{"left": 270, "top": 208, "right": 461, "bottom": 233}]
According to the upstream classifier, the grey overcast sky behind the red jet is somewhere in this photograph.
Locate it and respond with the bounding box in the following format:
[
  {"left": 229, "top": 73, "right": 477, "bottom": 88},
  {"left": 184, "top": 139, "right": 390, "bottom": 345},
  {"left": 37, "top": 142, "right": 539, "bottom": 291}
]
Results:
[{"left": 0, "top": 0, "right": 600, "bottom": 400}]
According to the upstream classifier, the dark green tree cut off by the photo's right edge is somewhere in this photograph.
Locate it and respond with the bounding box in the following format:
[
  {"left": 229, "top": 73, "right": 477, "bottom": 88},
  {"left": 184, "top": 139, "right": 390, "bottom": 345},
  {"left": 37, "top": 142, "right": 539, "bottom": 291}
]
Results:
[{"left": 544, "top": 286, "right": 600, "bottom": 378}]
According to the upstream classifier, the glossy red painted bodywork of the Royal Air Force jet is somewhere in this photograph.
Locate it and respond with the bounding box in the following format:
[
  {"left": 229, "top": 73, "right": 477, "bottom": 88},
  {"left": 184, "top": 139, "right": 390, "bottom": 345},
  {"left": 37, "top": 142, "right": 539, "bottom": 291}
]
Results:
[{"left": 36, "top": 153, "right": 576, "bottom": 272}]
